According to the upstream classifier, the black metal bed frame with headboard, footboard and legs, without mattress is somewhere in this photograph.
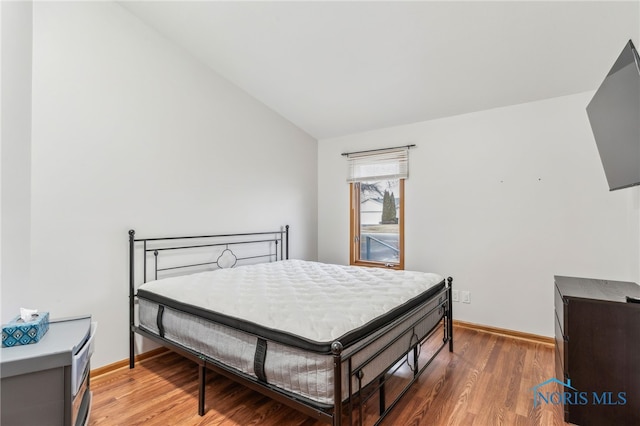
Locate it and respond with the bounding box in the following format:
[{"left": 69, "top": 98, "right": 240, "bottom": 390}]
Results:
[{"left": 129, "top": 225, "right": 453, "bottom": 426}]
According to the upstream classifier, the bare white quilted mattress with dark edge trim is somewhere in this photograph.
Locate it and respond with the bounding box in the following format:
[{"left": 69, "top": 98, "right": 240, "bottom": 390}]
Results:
[{"left": 138, "top": 260, "right": 444, "bottom": 404}]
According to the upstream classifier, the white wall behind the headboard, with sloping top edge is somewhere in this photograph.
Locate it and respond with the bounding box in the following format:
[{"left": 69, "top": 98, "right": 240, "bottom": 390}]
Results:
[{"left": 23, "top": 2, "right": 317, "bottom": 368}]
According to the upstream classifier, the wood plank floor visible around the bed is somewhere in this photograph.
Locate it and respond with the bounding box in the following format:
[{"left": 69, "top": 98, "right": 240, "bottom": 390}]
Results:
[{"left": 89, "top": 327, "right": 565, "bottom": 426}]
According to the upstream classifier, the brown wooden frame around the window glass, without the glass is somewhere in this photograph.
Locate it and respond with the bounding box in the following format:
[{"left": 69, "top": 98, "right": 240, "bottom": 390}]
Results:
[{"left": 349, "top": 178, "right": 405, "bottom": 270}]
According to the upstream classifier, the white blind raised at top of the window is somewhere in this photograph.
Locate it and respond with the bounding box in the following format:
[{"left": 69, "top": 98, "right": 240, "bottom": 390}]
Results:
[{"left": 347, "top": 147, "right": 409, "bottom": 182}]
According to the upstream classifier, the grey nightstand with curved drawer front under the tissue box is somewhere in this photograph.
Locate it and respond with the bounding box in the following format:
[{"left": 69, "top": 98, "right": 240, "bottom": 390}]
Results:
[{"left": 0, "top": 316, "right": 96, "bottom": 426}]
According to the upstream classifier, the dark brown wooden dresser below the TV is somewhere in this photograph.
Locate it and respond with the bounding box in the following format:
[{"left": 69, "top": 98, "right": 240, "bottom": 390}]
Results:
[{"left": 555, "top": 276, "right": 640, "bottom": 425}]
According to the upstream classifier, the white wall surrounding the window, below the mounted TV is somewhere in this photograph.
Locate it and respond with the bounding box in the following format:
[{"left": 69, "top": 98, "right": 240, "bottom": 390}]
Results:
[{"left": 318, "top": 93, "right": 640, "bottom": 336}]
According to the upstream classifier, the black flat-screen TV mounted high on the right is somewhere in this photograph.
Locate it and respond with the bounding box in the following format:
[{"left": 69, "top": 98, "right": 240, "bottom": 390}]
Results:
[{"left": 587, "top": 40, "right": 640, "bottom": 191}]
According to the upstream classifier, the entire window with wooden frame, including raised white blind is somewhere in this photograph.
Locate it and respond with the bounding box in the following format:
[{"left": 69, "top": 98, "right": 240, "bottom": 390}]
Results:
[{"left": 345, "top": 146, "right": 409, "bottom": 269}]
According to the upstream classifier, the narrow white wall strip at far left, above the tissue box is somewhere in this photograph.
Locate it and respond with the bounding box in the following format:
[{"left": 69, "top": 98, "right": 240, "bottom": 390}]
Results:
[{"left": 0, "top": 1, "right": 33, "bottom": 323}]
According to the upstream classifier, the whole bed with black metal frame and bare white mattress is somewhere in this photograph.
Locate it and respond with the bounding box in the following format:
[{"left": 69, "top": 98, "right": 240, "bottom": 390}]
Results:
[{"left": 129, "top": 226, "right": 453, "bottom": 425}]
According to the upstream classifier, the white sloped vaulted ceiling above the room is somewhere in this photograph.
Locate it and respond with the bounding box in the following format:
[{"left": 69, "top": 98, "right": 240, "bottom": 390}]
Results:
[{"left": 120, "top": 1, "right": 640, "bottom": 139}]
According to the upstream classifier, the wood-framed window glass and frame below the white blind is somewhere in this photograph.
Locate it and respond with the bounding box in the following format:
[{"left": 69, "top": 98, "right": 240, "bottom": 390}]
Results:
[{"left": 350, "top": 179, "right": 404, "bottom": 269}]
